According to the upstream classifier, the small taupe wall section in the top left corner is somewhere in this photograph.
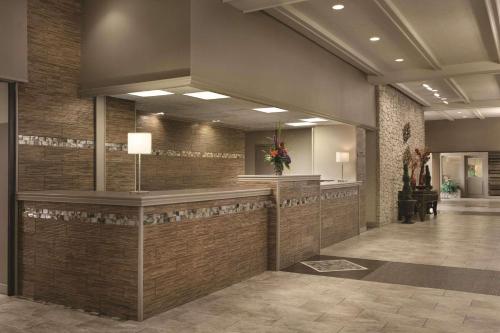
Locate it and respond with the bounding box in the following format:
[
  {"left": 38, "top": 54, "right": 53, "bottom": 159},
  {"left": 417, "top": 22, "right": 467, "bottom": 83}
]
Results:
[{"left": 0, "top": 0, "right": 28, "bottom": 82}]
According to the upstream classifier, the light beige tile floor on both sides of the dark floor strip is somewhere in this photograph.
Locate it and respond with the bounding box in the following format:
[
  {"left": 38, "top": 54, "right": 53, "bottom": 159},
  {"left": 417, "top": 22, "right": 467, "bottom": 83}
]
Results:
[{"left": 0, "top": 214, "right": 500, "bottom": 333}]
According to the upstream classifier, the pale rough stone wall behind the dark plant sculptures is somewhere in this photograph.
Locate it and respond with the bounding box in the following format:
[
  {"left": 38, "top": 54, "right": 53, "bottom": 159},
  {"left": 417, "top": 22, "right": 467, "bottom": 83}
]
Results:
[{"left": 377, "top": 86, "right": 425, "bottom": 225}]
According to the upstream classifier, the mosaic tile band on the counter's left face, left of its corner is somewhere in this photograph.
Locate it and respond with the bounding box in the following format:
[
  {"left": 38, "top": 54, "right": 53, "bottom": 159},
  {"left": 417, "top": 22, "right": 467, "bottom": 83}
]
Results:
[{"left": 23, "top": 208, "right": 137, "bottom": 226}]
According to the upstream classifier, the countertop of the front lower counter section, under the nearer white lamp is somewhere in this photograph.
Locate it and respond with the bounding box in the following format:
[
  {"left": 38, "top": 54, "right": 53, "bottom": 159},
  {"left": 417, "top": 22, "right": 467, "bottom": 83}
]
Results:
[{"left": 17, "top": 186, "right": 271, "bottom": 207}]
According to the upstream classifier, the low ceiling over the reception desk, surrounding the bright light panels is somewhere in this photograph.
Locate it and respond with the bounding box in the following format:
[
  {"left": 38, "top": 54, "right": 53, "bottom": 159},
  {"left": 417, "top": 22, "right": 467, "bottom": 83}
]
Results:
[{"left": 112, "top": 86, "right": 342, "bottom": 131}]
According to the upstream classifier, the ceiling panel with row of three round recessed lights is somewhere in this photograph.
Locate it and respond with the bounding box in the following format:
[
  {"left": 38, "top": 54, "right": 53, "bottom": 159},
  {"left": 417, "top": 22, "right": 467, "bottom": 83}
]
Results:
[{"left": 285, "top": 0, "right": 430, "bottom": 71}]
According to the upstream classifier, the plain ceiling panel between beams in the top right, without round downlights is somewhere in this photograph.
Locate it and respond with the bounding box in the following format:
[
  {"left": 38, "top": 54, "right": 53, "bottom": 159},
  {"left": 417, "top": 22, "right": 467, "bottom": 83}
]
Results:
[{"left": 392, "top": 0, "right": 496, "bottom": 65}]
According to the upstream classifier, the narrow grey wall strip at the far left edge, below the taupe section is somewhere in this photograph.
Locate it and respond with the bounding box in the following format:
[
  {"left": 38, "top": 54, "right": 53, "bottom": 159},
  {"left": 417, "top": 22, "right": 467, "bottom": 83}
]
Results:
[{"left": 0, "top": 82, "right": 9, "bottom": 293}]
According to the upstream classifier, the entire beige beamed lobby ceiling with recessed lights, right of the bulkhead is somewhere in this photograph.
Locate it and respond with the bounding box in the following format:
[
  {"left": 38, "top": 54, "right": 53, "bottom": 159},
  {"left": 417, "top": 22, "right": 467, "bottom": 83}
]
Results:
[{"left": 227, "top": 0, "right": 500, "bottom": 121}]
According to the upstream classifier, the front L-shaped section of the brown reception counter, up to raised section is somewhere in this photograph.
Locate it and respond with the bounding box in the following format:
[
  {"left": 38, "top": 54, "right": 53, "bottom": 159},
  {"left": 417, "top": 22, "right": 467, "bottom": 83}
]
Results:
[{"left": 18, "top": 188, "right": 272, "bottom": 320}]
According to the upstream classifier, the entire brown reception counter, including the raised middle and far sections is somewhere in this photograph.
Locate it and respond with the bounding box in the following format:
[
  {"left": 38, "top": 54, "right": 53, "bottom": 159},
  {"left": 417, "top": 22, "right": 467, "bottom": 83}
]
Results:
[{"left": 18, "top": 176, "right": 359, "bottom": 320}]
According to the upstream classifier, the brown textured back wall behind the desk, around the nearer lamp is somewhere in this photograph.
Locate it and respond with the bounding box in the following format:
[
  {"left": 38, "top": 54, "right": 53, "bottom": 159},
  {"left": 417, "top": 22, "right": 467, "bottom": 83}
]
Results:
[{"left": 106, "top": 97, "right": 245, "bottom": 191}]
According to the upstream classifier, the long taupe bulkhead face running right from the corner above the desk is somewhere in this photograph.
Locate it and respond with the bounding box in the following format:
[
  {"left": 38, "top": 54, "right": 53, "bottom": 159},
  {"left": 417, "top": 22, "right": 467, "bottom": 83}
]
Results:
[{"left": 191, "top": 0, "right": 375, "bottom": 127}]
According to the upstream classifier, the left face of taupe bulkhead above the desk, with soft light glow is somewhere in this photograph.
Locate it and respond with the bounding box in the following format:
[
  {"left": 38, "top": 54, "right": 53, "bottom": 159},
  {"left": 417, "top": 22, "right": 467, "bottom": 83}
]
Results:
[{"left": 82, "top": 0, "right": 190, "bottom": 88}]
